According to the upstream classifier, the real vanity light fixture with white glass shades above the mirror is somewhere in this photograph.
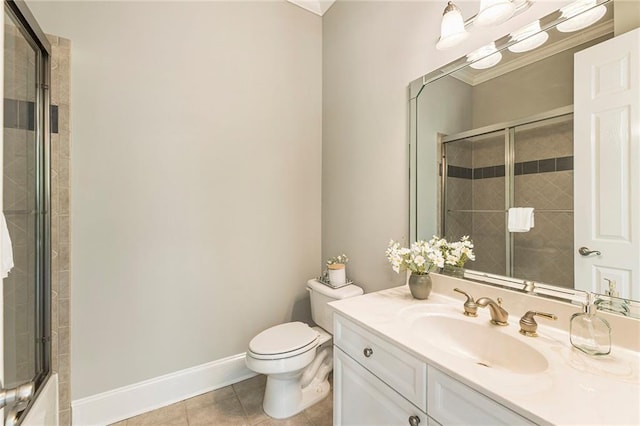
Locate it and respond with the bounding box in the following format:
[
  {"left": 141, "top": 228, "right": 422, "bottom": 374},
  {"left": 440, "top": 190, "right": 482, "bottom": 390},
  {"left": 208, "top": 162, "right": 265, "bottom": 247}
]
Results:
[{"left": 436, "top": 0, "right": 534, "bottom": 50}]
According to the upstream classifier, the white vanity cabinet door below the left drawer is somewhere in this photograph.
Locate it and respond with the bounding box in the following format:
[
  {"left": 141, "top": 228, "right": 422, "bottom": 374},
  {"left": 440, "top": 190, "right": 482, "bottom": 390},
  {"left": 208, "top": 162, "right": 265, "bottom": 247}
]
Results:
[{"left": 333, "top": 347, "right": 428, "bottom": 426}]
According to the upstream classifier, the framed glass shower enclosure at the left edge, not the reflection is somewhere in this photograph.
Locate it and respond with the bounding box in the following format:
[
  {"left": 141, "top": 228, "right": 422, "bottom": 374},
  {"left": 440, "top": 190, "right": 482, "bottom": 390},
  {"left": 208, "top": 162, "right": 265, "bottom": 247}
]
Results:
[{"left": 0, "top": 1, "right": 51, "bottom": 423}]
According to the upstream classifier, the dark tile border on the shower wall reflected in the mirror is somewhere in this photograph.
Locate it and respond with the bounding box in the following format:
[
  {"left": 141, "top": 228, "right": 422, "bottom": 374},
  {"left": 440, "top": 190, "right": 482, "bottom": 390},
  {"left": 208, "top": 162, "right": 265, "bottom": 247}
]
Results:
[{"left": 447, "top": 156, "right": 573, "bottom": 180}]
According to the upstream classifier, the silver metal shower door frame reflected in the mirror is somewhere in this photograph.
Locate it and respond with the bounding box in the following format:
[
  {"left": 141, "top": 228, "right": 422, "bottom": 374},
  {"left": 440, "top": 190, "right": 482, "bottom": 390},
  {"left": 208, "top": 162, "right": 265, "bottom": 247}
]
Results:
[{"left": 439, "top": 105, "right": 573, "bottom": 277}]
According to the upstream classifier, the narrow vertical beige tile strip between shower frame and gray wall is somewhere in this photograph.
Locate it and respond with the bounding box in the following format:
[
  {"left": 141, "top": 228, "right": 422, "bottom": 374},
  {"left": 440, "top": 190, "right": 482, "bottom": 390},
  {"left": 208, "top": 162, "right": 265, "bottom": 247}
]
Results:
[{"left": 48, "top": 36, "right": 71, "bottom": 426}]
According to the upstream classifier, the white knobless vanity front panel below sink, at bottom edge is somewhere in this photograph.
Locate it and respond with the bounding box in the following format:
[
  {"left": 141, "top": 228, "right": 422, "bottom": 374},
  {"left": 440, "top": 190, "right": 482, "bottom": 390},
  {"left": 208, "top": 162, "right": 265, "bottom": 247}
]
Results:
[{"left": 427, "top": 366, "right": 533, "bottom": 425}]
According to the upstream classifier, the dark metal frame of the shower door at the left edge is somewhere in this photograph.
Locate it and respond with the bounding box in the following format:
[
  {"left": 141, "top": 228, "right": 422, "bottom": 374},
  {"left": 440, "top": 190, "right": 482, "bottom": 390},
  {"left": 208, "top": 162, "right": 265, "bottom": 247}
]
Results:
[{"left": 0, "top": 0, "right": 52, "bottom": 422}]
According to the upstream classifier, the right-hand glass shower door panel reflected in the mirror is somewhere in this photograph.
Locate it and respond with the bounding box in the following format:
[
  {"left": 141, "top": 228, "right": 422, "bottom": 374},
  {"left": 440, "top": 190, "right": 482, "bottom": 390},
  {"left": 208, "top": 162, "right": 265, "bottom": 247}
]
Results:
[{"left": 512, "top": 114, "right": 573, "bottom": 288}]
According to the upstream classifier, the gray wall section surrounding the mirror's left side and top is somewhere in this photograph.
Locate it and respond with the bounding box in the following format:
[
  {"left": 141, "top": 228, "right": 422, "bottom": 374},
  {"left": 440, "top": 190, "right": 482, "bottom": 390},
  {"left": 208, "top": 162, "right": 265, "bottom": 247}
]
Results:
[{"left": 322, "top": 1, "right": 568, "bottom": 291}]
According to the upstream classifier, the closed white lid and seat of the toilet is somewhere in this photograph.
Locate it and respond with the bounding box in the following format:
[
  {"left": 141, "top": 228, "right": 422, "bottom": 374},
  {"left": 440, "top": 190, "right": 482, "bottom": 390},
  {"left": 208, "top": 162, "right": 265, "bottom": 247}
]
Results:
[{"left": 249, "top": 322, "right": 318, "bottom": 358}]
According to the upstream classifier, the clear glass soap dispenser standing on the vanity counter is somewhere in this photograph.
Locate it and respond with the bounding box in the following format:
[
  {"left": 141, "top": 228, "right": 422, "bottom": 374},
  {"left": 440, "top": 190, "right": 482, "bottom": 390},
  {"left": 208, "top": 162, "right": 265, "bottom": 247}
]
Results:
[{"left": 569, "top": 293, "right": 611, "bottom": 355}]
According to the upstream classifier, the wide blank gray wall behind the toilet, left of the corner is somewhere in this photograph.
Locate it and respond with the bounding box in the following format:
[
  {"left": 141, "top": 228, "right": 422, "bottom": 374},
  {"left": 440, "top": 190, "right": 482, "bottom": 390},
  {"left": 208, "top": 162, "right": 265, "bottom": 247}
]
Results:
[{"left": 30, "top": 2, "right": 322, "bottom": 400}]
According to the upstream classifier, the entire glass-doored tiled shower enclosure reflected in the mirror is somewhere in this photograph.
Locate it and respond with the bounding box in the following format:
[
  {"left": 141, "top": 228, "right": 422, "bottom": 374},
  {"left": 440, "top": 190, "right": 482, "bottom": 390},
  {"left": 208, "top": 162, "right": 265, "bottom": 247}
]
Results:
[{"left": 440, "top": 108, "right": 573, "bottom": 288}]
